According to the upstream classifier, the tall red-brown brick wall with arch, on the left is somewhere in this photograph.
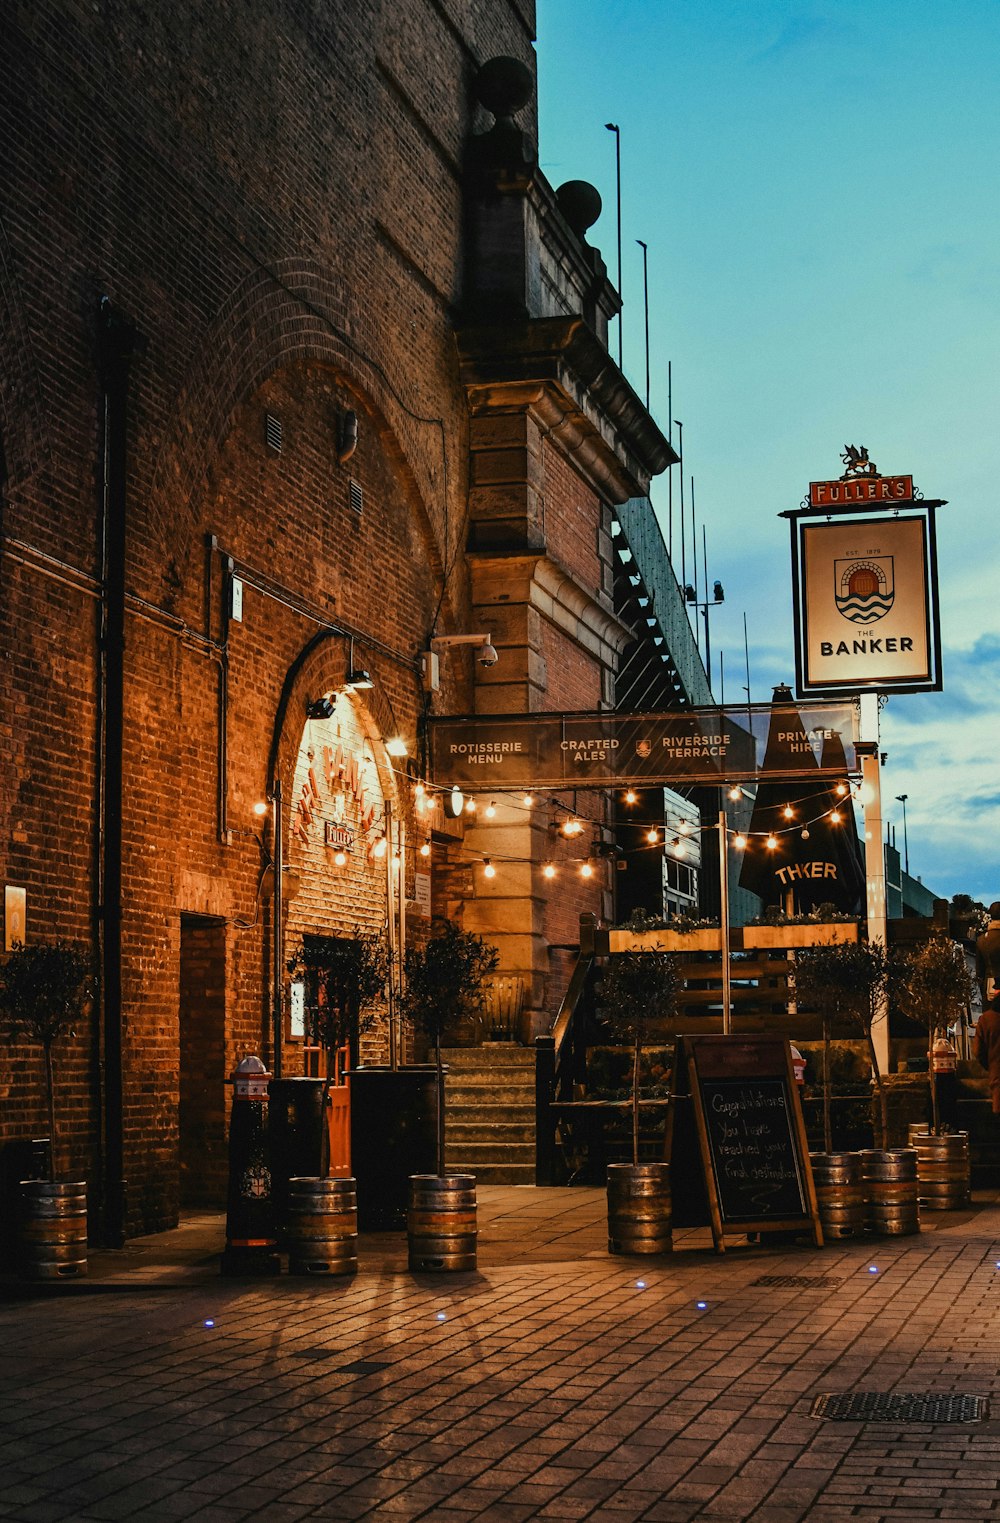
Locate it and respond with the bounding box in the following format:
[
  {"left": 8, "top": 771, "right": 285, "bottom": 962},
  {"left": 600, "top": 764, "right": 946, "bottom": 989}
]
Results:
[{"left": 0, "top": 0, "right": 533, "bottom": 1232}]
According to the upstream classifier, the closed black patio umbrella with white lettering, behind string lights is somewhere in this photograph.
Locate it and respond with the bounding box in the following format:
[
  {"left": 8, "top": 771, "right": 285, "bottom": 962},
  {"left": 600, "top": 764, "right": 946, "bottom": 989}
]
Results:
[{"left": 740, "top": 687, "right": 865, "bottom": 915}]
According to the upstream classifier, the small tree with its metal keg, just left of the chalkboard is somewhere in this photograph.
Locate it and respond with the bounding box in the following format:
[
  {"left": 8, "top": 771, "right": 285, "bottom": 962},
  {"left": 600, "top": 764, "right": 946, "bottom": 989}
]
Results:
[{"left": 600, "top": 914, "right": 677, "bottom": 1253}]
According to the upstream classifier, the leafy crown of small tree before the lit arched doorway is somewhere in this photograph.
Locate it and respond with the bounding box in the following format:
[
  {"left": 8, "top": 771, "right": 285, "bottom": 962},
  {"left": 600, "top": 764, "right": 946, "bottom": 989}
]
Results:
[{"left": 288, "top": 928, "right": 388, "bottom": 1052}]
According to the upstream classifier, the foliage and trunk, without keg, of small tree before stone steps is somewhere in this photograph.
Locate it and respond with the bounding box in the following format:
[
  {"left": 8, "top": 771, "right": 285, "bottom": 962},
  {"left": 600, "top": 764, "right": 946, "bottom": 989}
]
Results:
[{"left": 399, "top": 920, "right": 499, "bottom": 1174}]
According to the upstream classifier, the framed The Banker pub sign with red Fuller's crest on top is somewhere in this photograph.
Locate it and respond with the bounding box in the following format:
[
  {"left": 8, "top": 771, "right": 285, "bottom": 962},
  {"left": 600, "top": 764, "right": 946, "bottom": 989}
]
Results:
[{"left": 782, "top": 445, "right": 944, "bottom": 698}]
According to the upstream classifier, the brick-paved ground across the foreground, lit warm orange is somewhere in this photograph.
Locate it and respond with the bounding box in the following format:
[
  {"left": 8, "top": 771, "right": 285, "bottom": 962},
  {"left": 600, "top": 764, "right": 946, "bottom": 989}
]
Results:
[{"left": 0, "top": 1186, "right": 1000, "bottom": 1523}]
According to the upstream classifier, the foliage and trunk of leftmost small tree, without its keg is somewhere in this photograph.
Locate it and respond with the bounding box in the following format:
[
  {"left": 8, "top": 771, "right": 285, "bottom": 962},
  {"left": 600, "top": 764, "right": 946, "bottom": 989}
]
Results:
[{"left": 0, "top": 941, "right": 93, "bottom": 1183}]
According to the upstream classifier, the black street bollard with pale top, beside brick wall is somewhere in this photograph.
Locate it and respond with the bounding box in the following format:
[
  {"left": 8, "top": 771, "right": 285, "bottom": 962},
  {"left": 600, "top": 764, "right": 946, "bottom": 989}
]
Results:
[{"left": 221, "top": 1057, "right": 282, "bottom": 1275}]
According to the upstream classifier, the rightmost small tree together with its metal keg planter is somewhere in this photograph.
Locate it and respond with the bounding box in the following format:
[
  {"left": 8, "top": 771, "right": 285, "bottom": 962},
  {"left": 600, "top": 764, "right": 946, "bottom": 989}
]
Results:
[{"left": 900, "top": 935, "right": 976, "bottom": 1209}]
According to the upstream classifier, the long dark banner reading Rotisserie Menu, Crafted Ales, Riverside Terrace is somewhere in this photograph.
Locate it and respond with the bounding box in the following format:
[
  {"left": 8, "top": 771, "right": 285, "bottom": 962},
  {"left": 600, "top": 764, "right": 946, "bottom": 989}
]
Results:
[{"left": 429, "top": 704, "right": 857, "bottom": 792}]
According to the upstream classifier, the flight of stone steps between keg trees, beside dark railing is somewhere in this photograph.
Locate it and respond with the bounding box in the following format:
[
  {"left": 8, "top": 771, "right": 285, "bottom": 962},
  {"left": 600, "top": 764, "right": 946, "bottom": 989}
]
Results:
[{"left": 441, "top": 1042, "right": 534, "bottom": 1185}]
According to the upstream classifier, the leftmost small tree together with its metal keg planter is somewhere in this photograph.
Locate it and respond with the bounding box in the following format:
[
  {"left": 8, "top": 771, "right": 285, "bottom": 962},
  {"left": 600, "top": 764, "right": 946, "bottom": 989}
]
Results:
[{"left": 0, "top": 941, "right": 93, "bottom": 1279}]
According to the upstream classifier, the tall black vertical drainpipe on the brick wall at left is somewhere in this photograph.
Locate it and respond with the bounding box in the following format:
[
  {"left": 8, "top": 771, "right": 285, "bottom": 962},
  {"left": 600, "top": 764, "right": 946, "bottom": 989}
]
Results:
[{"left": 97, "top": 297, "right": 137, "bottom": 1247}]
